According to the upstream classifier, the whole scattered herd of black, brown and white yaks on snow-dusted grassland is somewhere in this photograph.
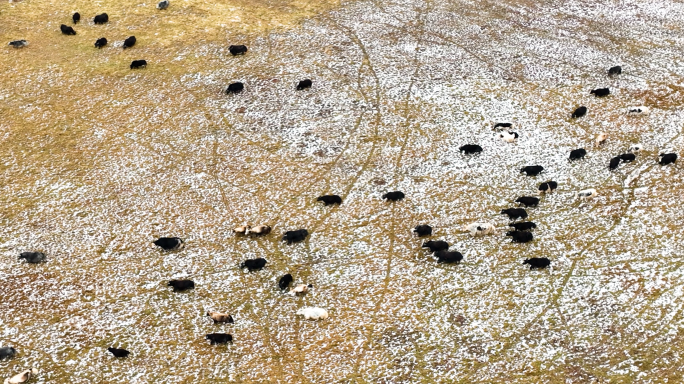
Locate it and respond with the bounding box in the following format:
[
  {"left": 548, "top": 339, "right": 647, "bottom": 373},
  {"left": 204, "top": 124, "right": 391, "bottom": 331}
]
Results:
[{"left": 0, "top": 0, "right": 677, "bottom": 384}]
